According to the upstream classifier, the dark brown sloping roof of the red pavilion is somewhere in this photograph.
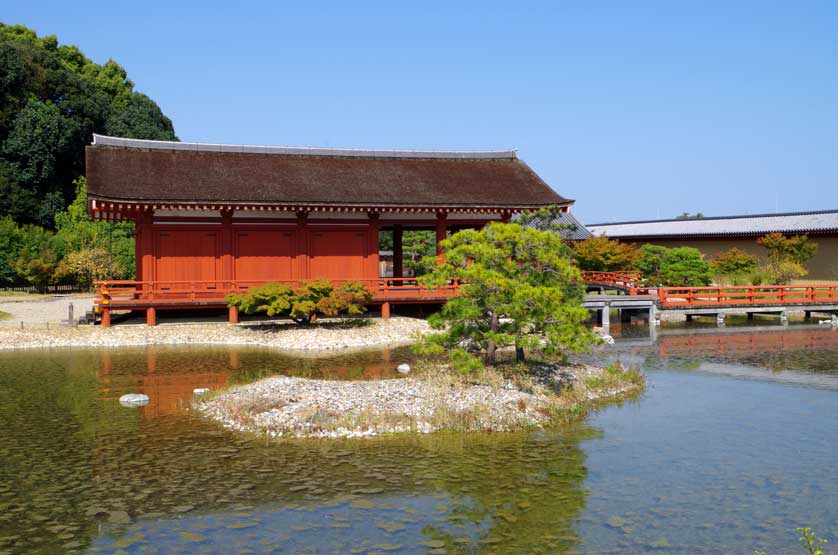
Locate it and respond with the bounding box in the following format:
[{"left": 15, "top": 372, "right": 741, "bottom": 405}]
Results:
[{"left": 87, "top": 136, "right": 573, "bottom": 209}]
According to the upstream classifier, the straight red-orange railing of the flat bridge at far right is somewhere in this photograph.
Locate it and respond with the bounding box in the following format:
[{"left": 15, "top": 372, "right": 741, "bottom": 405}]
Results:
[{"left": 658, "top": 285, "right": 838, "bottom": 307}]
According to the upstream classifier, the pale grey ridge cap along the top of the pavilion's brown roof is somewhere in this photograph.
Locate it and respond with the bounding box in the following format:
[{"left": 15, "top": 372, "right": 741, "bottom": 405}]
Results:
[{"left": 93, "top": 133, "right": 518, "bottom": 159}]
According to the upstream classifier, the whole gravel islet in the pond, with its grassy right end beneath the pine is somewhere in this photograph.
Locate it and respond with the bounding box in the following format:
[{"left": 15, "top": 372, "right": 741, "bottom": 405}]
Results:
[{"left": 192, "top": 364, "right": 644, "bottom": 438}]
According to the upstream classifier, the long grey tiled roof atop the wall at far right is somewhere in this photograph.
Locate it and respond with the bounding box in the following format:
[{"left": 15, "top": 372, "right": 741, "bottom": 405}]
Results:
[{"left": 587, "top": 210, "right": 838, "bottom": 239}]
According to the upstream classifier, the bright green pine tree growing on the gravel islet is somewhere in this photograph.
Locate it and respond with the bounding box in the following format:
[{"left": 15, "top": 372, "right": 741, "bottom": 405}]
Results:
[{"left": 422, "top": 223, "right": 594, "bottom": 370}]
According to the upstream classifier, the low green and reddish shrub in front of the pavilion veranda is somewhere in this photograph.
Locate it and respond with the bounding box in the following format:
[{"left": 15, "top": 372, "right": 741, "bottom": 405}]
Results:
[{"left": 227, "top": 279, "right": 372, "bottom": 324}]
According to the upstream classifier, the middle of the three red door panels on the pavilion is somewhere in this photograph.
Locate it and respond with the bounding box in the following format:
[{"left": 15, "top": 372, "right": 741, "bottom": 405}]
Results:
[{"left": 235, "top": 230, "right": 296, "bottom": 281}]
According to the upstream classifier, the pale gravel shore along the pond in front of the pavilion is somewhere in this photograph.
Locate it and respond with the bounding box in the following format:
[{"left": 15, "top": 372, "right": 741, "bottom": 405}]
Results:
[{"left": 0, "top": 317, "right": 430, "bottom": 352}]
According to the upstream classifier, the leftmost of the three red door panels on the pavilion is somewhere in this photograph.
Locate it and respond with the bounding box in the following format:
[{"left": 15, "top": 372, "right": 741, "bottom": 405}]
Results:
[{"left": 155, "top": 230, "right": 218, "bottom": 288}]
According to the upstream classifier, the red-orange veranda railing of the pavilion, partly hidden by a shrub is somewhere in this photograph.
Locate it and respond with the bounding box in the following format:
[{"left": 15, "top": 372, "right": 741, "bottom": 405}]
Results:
[{"left": 96, "top": 278, "right": 459, "bottom": 308}]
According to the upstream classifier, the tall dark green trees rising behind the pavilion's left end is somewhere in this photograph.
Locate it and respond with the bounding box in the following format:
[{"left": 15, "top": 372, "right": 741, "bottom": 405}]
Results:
[{"left": 0, "top": 23, "right": 177, "bottom": 228}]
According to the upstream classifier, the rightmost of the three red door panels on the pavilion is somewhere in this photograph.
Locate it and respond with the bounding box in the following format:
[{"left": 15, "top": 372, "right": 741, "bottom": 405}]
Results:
[{"left": 308, "top": 231, "right": 368, "bottom": 280}]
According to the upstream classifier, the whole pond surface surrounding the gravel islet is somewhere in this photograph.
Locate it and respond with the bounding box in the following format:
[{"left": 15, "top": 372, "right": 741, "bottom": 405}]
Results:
[{"left": 0, "top": 326, "right": 838, "bottom": 554}]
